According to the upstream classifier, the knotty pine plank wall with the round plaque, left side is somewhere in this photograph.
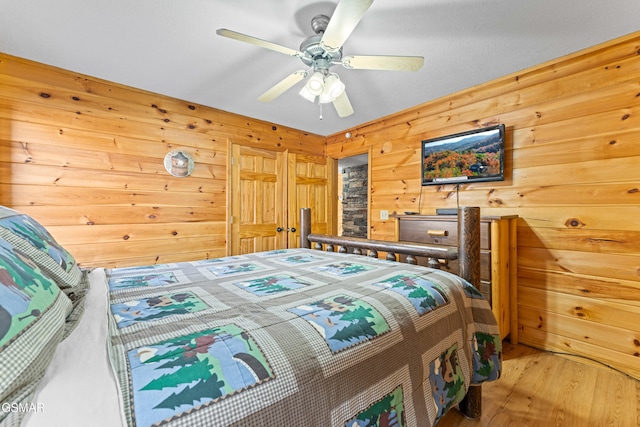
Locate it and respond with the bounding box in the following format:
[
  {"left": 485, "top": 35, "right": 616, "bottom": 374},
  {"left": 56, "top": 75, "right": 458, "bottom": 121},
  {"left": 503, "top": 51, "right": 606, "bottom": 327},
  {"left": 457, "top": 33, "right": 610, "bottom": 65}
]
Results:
[{"left": 0, "top": 54, "right": 325, "bottom": 266}]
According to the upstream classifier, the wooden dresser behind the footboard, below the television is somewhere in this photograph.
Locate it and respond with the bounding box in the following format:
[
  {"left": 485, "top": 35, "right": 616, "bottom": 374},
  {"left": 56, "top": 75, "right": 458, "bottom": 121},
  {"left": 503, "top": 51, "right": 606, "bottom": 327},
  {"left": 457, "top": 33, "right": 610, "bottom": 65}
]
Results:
[{"left": 395, "top": 215, "right": 518, "bottom": 344}]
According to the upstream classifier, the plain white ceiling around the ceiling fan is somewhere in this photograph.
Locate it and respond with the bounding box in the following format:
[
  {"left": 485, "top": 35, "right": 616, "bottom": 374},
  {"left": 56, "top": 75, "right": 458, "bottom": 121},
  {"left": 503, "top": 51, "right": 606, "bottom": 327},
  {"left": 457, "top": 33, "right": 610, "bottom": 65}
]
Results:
[{"left": 0, "top": 0, "right": 640, "bottom": 135}]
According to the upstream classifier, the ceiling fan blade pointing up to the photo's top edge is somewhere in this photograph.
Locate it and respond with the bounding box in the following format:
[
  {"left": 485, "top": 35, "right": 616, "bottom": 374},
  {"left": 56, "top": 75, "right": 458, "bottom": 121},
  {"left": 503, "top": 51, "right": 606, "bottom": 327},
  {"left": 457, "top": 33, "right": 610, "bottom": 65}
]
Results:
[{"left": 320, "top": 0, "right": 373, "bottom": 51}]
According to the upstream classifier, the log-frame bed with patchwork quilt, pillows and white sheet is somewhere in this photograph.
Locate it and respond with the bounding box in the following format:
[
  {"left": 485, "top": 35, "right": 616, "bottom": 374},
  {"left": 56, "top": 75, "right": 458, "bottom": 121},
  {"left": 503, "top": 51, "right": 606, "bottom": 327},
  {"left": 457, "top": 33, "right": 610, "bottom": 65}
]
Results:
[{"left": 0, "top": 208, "right": 501, "bottom": 427}]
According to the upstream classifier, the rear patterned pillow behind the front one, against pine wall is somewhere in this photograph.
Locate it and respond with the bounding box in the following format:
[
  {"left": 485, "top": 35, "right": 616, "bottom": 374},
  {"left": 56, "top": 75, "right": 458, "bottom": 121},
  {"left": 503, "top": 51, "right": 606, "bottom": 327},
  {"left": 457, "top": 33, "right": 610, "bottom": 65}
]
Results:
[{"left": 0, "top": 206, "right": 89, "bottom": 336}]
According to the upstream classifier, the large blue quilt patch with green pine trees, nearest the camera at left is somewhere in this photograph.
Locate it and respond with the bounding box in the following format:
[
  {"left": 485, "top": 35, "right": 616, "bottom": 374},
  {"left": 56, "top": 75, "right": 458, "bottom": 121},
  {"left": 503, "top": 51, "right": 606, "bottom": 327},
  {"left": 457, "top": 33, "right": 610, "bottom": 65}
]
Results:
[{"left": 128, "top": 324, "right": 273, "bottom": 426}]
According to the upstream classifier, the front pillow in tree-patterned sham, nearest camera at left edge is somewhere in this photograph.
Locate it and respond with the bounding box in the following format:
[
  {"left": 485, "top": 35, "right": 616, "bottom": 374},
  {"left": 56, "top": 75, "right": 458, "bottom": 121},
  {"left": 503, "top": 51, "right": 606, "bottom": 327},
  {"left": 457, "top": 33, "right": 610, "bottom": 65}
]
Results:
[{"left": 0, "top": 239, "right": 72, "bottom": 425}]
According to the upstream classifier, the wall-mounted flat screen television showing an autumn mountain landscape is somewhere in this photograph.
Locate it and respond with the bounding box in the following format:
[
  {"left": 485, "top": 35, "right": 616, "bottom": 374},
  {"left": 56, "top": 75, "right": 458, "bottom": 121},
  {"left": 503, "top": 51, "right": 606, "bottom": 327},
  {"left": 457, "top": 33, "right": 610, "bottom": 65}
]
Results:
[{"left": 422, "top": 124, "right": 504, "bottom": 185}]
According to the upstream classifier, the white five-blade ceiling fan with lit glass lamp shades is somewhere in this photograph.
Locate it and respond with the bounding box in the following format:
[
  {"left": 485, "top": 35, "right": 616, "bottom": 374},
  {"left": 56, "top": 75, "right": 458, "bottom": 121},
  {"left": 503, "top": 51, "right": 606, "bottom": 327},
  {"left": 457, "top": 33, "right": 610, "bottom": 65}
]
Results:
[{"left": 216, "top": 0, "right": 424, "bottom": 117}]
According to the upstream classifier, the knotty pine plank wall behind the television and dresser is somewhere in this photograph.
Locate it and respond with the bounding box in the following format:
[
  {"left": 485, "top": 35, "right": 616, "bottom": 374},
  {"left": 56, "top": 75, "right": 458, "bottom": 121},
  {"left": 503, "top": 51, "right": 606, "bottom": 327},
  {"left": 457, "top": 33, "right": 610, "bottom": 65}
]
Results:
[{"left": 327, "top": 32, "right": 640, "bottom": 378}]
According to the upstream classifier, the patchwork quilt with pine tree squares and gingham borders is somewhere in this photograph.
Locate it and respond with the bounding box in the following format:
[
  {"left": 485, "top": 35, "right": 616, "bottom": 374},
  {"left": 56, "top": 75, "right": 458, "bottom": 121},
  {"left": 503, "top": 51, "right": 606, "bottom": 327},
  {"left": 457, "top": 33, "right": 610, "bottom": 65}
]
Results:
[{"left": 106, "top": 249, "right": 501, "bottom": 427}]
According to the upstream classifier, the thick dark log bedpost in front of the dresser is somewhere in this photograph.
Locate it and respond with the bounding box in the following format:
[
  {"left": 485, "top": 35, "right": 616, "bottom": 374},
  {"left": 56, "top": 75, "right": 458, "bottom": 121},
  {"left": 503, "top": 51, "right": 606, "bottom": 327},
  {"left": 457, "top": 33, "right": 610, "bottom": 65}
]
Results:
[{"left": 458, "top": 207, "right": 482, "bottom": 420}]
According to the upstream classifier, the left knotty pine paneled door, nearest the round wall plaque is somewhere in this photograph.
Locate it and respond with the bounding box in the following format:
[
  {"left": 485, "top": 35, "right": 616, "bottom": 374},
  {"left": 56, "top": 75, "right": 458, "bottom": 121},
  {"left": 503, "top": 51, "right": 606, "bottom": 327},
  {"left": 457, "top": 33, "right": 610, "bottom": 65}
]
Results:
[{"left": 229, "top": 144, "right": 287, "bottom": 255}]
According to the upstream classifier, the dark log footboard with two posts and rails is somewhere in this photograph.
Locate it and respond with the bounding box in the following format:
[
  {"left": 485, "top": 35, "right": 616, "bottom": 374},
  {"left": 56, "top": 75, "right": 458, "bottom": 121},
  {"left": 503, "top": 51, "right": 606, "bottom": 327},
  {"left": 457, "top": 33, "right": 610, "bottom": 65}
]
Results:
[{"left": 300, "top": 207, "right": 482, "bottom": 419}]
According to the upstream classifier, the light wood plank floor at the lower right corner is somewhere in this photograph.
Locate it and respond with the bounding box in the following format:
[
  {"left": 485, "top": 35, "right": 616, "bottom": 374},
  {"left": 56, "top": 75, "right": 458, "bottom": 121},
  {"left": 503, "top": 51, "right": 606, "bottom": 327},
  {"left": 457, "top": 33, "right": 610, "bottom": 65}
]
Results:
[{"left": 438, "top": 341, "right": 640, "bottom": 427}]
